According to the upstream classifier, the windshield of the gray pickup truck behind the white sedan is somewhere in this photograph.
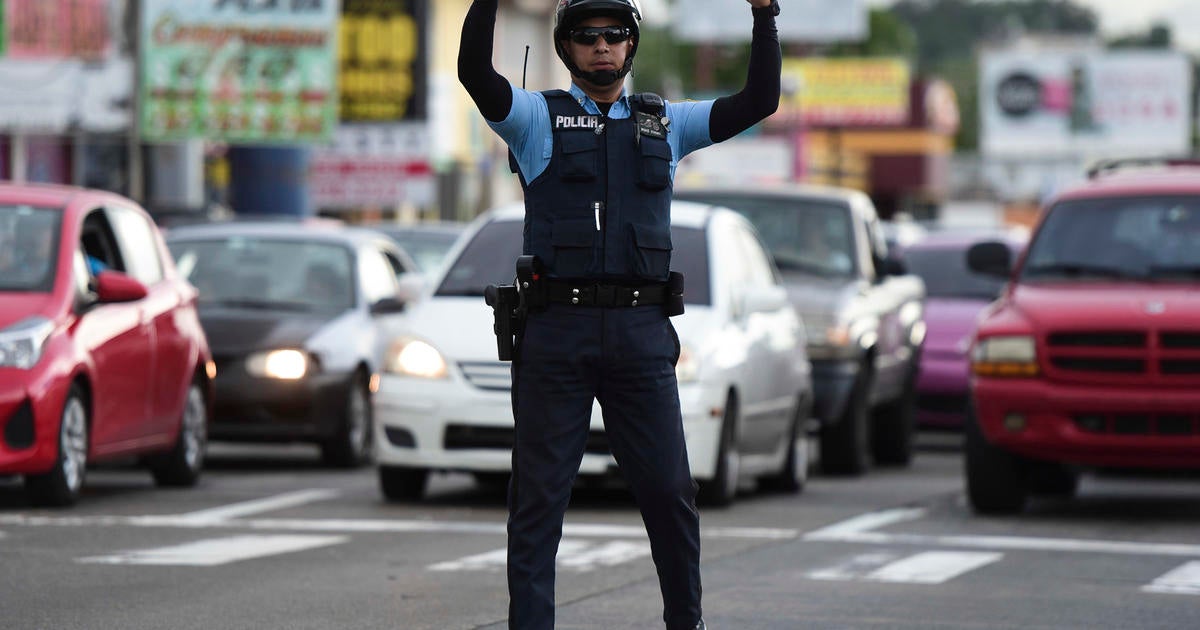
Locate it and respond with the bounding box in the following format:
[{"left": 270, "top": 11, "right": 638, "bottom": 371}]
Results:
[{"left": 704, "top": 196, "right": 854, "bottom": 276}]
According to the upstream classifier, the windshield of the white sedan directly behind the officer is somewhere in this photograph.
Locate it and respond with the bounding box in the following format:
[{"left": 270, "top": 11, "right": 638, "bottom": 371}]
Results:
[{"left": 436, "top": 221, "right": 710, "bottom": 305}]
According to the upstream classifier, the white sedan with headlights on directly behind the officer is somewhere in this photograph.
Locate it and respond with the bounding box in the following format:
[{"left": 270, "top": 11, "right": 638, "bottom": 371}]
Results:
[{"left": 374, "top": 202, "right": 812, "bottom": 505}]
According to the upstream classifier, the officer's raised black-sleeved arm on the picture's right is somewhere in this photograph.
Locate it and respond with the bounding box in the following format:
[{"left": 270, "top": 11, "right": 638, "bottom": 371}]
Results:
[{"left": 705, "top": 0, "right": 784, "bottom": 142}]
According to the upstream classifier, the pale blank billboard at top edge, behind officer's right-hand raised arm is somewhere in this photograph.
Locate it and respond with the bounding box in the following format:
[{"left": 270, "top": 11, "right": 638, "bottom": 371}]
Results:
[{"left": 671, "top": 0, "right": 866, "bottom": 43}]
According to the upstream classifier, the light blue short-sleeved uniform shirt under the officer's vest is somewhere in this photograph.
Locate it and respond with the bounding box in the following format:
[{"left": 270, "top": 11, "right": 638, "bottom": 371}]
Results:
[{"left": 487, "top": 83, "right": 713, "bottom": 182}]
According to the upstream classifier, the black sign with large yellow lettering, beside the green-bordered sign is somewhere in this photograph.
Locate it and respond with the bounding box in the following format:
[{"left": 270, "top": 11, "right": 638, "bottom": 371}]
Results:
[{"left": 338, "top": 0, "right": 427, "bottom": 122}]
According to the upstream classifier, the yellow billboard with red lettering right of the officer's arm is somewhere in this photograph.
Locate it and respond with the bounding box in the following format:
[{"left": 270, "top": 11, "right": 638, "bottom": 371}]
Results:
[{"left": 776, "top": 58, "right": 911, "bottom": 127}]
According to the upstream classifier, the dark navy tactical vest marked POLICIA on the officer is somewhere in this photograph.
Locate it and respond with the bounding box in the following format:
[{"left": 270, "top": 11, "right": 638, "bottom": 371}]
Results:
[{"left": 522, "top": 90, "right": 671, "bottom": 283}]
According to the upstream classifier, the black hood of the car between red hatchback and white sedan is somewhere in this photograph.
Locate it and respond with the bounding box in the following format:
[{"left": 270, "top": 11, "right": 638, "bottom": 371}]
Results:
[{"left": 200, "top": 307, "right": 340, "bottom": 355}]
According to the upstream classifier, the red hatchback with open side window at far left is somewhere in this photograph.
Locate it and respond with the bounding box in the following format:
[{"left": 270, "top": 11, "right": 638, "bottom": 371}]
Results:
[{"left": 0, "top": 185, "right": 215, "bottom": 505}]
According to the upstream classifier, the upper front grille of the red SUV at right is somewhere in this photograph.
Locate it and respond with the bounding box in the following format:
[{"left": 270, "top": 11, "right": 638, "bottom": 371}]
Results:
[{"left": 1044, "top": 330, "right": 1200, "bottom": 385}]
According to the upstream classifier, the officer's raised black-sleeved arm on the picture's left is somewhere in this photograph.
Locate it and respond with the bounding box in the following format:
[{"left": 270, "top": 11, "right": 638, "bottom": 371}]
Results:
[{"left": 458, "top": 0, "right": 513, "bottom": 122}]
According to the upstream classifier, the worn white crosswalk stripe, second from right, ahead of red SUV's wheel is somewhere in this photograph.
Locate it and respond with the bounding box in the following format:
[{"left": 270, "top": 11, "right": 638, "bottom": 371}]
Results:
[{"left": 808, "top": 551, "right": 1004, "bottom": 584}]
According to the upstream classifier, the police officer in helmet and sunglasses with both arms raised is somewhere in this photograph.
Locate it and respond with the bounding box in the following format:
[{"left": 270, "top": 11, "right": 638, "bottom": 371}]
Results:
[{"left": 458, "top": 0, "right": 781, "bottom": 630}]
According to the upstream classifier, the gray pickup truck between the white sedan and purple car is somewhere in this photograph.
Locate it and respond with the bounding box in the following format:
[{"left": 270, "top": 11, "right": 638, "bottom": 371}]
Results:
[{"left": 676, "top": 186, "right": 925, "bottom": 474}]
